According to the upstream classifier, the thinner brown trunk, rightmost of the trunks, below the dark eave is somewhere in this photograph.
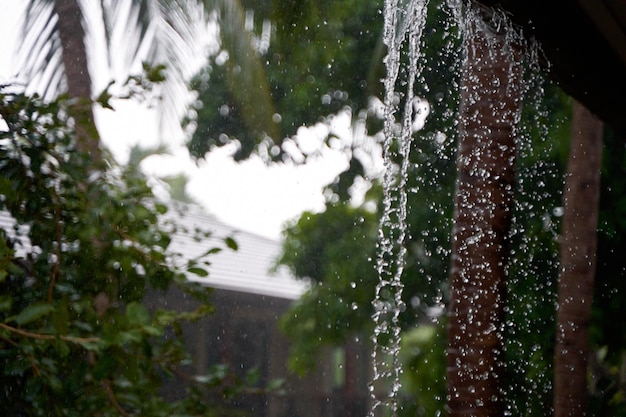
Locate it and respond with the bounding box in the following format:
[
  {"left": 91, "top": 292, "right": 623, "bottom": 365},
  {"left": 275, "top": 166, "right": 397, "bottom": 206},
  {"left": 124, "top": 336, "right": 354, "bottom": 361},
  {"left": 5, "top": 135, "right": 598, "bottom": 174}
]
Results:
[{"left": 554, "top": 102, "right": 602, "bottom": 417}]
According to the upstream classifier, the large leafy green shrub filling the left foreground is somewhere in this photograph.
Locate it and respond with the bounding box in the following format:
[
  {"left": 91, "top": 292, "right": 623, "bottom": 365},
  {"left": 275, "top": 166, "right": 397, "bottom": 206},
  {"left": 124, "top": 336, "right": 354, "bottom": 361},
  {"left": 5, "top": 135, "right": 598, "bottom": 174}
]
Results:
[{"left": 0, "top": 90, "right": 251, "bottom": 416}]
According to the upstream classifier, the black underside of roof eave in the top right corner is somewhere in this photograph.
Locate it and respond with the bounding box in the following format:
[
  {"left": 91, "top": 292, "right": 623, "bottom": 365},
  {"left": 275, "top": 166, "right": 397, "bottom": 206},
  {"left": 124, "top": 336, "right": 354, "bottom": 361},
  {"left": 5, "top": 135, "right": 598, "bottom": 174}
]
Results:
[{"left": 481, "top": 0, "right": 626, "bottom": 133}]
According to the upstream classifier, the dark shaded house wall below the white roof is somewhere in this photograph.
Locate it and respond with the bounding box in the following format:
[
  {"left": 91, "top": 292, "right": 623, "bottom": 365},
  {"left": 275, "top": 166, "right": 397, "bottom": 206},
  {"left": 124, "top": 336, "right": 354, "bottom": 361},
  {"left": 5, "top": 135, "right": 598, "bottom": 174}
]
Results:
[{"left": 146, "top": 290, "right": 370, "bottom": 417}]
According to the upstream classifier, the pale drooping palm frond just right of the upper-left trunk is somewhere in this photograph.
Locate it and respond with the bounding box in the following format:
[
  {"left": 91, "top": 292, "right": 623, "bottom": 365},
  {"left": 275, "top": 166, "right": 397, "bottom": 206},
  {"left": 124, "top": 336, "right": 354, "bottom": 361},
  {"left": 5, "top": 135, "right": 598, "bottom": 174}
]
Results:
[{"left": 102, "top": 0, "right": 206, "bottom": 138}]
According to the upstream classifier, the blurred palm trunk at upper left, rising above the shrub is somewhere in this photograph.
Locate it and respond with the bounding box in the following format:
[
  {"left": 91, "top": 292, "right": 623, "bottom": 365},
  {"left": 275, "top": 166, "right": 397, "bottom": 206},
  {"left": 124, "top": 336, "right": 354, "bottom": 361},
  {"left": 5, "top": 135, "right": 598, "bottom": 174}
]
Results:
[{"left": 54, "top": 0, "right": 102, "bottom": 165}]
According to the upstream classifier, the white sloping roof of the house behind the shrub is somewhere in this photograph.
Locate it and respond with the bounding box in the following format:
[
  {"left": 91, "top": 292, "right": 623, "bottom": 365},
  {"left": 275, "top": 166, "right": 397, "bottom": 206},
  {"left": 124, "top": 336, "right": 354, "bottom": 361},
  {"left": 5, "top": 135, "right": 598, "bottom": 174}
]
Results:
[{"left": 0, "top": 206, "right": 308, "bottom": 300}]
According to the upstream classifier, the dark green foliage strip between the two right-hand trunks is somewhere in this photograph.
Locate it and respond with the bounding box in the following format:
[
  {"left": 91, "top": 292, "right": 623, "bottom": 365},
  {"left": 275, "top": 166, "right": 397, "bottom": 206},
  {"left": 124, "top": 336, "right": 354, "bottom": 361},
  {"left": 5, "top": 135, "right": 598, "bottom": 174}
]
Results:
[{"left": 505, "top": 79, "right": 571, "bottom": 416}]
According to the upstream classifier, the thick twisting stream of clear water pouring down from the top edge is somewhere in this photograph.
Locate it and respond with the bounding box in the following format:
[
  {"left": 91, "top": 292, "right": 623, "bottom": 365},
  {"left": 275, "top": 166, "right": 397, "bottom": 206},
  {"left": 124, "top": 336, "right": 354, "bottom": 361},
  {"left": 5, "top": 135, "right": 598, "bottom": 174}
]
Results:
[{"left": 369, "top": 0, "right": 428, "bottom": 416}]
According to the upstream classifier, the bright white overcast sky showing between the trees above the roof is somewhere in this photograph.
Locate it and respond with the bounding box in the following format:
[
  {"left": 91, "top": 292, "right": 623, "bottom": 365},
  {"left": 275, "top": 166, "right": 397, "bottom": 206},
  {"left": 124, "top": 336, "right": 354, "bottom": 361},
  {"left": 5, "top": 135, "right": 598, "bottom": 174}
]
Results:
[{"left": 0, "top": 0, "right": 356, "bottom": 238}]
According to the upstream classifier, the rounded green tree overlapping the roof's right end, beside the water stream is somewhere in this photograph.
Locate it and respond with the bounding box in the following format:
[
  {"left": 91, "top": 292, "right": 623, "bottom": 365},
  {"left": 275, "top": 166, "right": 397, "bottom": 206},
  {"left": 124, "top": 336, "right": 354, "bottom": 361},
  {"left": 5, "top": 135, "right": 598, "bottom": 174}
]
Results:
[{"left": 278, "top": 204, "right": 377, "bottom": 374}]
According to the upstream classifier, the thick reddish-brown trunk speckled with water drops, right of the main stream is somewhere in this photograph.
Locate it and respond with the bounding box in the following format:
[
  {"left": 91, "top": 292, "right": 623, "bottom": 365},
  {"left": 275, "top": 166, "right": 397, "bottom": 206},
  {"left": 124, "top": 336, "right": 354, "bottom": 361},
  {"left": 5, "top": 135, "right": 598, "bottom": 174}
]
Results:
[{"left": 447, "top": 7, "right": 521, "bottom": 417}]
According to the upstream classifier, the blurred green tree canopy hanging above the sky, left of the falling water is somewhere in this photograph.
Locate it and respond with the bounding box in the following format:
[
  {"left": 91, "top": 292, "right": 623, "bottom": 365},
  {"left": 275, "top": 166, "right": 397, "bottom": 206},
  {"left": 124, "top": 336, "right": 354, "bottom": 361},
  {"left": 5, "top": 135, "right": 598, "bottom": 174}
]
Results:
[{"left": 187, "top": 0, "right": 383, "bottom": 159}]
